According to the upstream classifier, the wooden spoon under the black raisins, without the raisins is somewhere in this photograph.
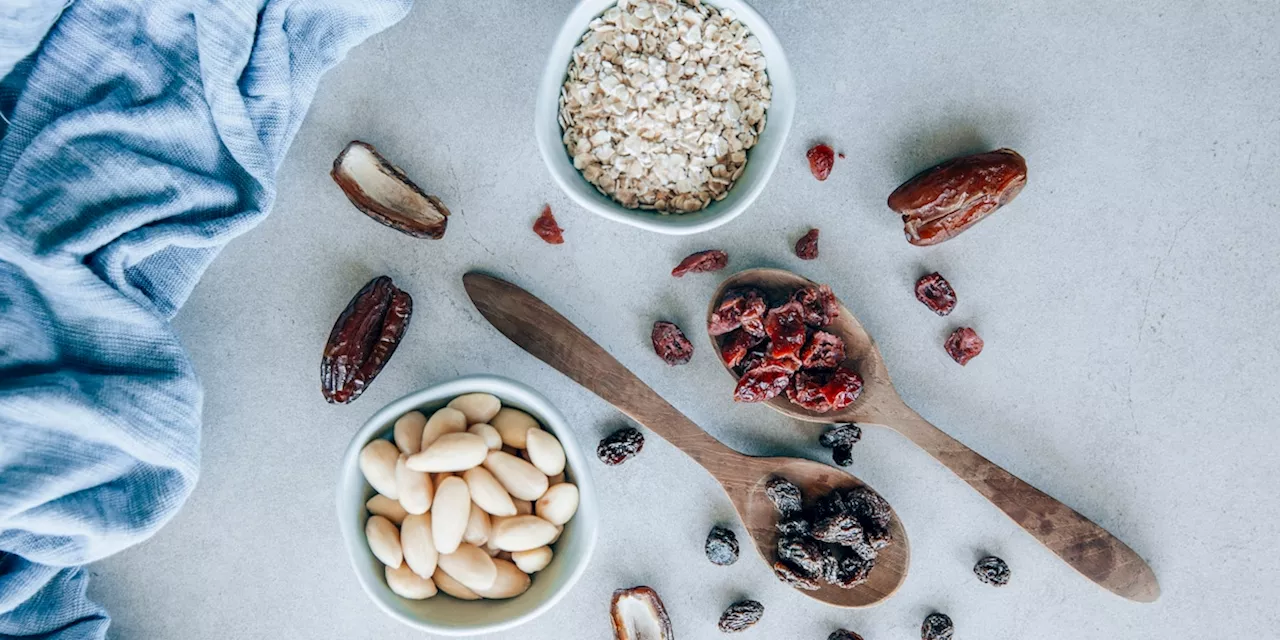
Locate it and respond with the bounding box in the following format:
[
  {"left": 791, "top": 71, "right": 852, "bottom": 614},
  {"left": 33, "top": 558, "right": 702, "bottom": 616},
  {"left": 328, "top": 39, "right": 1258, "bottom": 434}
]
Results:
[{"left": 462, "top": 273, "right": 910, "bottom": 607}]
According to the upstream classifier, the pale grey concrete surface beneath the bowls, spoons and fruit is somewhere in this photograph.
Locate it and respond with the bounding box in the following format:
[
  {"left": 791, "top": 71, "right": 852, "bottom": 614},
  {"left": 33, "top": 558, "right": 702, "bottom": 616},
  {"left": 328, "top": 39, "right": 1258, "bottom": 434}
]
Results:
[{"left": 85, "top": 0, "right": 1280, "bottom": 640}]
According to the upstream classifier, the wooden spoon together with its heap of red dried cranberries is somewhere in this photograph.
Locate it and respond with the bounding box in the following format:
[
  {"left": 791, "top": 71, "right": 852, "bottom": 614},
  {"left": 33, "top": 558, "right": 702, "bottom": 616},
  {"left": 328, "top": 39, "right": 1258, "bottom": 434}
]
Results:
[{"left": 707, "top": 269, "right": 1160, "bottom": 602}]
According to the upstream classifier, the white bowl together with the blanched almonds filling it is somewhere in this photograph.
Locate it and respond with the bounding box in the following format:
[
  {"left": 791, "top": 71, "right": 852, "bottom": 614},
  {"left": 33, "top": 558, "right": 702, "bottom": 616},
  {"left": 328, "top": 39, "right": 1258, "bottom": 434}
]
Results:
[{"left": 338, "top": 375, "right": 598, "bottom": 636}]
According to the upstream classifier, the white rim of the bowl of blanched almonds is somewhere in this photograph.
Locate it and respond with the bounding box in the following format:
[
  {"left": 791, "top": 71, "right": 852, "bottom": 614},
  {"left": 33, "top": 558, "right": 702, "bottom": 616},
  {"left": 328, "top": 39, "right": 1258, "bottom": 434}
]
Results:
[{"left": 334, "top": 374, "right": 599, "bottom": 636}]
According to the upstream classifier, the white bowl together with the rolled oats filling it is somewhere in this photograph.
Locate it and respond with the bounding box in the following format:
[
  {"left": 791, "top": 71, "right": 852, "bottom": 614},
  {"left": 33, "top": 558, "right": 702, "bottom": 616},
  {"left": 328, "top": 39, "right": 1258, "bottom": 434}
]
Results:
[{"left": 535, "top": 0, "right": 795, "bottom": 234}]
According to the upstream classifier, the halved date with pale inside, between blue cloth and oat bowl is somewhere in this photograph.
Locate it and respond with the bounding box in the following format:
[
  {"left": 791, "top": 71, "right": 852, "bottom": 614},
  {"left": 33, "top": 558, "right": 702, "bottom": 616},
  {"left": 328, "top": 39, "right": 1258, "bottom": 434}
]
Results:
[{"left": 329, "top": 140, "right": 449, "bottom": 239}]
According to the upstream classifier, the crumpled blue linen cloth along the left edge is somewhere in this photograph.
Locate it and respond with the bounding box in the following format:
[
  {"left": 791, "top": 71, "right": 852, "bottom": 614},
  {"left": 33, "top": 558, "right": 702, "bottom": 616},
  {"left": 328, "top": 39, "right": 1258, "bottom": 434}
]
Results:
[{"left": 0, "top": 0, "right": 412, "bottom": 639}]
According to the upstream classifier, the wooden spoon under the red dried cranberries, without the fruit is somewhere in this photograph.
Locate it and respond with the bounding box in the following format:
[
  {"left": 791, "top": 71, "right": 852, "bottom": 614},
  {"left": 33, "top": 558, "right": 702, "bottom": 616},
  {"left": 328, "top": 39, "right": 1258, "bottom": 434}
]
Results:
[{"left": 707, "top": 269, "right": 1160, "bottom": 602}]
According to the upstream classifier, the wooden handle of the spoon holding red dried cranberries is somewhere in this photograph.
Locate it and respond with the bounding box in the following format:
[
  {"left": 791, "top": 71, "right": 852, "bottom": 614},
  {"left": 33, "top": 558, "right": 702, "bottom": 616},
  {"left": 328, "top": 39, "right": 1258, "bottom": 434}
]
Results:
[{"left": 883, "top": 407, "right": 1160, "bottom": 603}]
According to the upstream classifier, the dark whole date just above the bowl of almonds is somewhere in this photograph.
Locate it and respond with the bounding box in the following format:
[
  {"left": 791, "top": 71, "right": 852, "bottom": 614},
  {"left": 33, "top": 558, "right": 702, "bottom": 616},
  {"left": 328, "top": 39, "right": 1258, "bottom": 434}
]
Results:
[{"left": 320, "top": 275, "right": 413, "bottom": 403}]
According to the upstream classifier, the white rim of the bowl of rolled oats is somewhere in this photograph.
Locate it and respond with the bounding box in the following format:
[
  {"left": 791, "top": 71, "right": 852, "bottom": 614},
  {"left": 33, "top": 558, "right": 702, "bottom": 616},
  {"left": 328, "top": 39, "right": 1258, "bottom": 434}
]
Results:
[{"left": 534, "top": 0, "right": 796, "bottom": 236}]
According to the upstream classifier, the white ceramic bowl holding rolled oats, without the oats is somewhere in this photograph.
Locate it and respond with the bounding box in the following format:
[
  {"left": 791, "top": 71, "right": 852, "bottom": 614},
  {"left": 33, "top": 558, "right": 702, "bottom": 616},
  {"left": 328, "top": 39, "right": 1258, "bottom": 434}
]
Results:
[{"left": 534, "top": 0, "right": 796, "bottom": 236}]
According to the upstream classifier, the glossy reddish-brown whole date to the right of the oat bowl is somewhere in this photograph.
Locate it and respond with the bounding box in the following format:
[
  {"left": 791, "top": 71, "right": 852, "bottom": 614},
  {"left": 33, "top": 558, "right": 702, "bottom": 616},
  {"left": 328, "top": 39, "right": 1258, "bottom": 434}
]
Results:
[{"left": 888, "top": 148, "right": 1027, "bottom": 246}]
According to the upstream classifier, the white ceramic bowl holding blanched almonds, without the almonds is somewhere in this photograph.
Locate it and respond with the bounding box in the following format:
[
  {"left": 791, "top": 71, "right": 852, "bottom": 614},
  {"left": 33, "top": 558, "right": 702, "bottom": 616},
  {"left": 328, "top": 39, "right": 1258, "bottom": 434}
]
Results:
[{"left": 338, "top": 375, "right": 599, "bottom": 636}]
